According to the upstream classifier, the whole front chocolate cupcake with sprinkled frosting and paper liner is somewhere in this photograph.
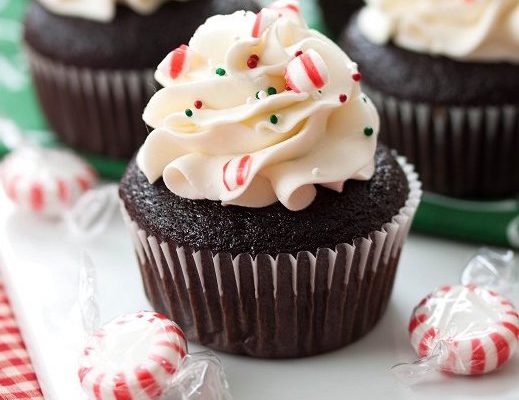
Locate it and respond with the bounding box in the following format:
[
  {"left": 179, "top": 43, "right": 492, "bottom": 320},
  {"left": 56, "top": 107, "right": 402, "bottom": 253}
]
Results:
[{"left": 120, "top": 2, "right": 420, "bottom": 358}]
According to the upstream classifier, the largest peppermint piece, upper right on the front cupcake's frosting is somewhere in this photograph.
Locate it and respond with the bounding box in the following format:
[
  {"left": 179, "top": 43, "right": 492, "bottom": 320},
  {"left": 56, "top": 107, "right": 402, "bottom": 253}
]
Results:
[{"left": 285, "top": 49, "right": 329, "bottom": 93}]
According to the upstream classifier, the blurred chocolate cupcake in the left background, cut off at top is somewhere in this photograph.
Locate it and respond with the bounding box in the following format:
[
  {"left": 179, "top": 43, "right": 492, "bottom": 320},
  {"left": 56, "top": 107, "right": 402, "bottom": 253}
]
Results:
[{"left": 24, "top": 0, "right": 257, "bottom": 159}]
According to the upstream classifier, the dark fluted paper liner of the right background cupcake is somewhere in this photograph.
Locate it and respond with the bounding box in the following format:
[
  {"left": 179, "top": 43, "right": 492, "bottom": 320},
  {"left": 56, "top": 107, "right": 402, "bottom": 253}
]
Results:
[{"left": 363, "top": 84, "right": 519, "bottom": 197}]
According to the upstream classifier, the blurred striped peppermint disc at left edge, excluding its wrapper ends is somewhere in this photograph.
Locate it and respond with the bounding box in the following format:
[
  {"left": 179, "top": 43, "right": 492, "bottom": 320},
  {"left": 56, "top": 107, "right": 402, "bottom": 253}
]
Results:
[{"left": 1, "top": 147, "right": 97, "bottom": 216}]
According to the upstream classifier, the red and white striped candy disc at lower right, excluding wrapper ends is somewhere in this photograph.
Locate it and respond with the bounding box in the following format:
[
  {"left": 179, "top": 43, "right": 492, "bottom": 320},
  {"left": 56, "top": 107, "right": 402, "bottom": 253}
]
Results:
[{"left": 409, "top": 285, "right": 519, "bottom": 375}]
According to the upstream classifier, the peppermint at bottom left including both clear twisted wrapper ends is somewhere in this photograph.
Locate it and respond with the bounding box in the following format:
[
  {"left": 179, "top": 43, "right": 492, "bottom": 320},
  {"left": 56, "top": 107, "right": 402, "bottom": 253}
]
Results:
[{"left": 78, "top": 254, "right": 232, "bottom": 400}]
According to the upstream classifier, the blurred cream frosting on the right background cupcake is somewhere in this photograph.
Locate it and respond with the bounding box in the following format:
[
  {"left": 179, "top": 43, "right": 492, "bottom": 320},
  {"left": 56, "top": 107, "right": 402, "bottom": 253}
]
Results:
[{"left": 359, "top": 0, "right": 519, "bottom": 62}]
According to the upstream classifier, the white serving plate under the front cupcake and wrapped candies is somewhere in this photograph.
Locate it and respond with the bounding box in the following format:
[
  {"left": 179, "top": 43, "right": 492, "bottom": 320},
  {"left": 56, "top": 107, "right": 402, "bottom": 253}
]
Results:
[{"left": 0, "top": 192, "right": 519, "bottom": 400}]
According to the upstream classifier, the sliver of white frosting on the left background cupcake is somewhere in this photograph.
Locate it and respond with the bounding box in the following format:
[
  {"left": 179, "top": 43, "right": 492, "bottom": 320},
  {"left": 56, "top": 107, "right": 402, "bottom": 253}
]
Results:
[{"left": 38, "top": 0, "right": 188, "bottom": 22}]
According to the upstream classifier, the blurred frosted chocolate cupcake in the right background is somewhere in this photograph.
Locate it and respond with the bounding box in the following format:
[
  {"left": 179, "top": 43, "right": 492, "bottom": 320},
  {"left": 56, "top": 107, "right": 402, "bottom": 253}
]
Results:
[{"left": 341, "top": 0, "right": 519, "bottom": 198}]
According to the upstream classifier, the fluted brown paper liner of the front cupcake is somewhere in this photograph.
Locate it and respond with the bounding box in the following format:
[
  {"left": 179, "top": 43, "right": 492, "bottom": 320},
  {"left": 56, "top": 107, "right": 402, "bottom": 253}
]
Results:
[{"left": 122, "top": 159, "right": 421, "bottom": 358}]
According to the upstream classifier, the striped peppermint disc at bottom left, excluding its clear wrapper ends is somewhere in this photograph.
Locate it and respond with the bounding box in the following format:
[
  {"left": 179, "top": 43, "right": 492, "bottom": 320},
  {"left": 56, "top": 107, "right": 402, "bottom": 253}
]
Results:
[{"left": 78, "top": 311, "right": 187, "bottom": 400}]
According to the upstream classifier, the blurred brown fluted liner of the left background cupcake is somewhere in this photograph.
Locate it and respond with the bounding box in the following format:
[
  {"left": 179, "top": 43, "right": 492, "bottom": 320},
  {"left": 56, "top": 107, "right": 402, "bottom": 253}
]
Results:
[{"left": 26, "top": 47, "right": 156, "bottom": 159}]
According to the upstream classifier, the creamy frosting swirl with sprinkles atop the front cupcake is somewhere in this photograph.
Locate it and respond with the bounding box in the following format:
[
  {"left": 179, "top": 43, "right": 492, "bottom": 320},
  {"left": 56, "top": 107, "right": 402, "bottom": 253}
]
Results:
[{"left": 137, "top": 4, "right": 379, "bottom": 210}]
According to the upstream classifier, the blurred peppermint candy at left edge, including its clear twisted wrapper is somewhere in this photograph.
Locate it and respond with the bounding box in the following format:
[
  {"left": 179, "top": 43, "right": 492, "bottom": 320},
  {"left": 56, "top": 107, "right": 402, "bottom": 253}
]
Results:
[{"left": 0, "top": 119, "right": 119, "bottom": 237}]
